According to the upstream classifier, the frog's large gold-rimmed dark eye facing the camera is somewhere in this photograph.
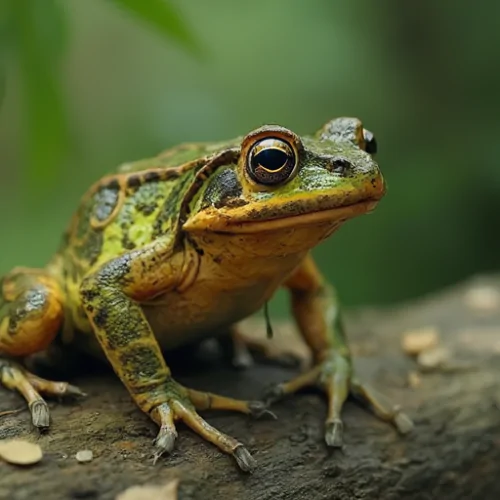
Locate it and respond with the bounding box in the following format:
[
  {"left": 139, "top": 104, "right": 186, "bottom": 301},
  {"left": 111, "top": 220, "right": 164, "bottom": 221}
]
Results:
[{"left": 247, "top": 137, "right": 297, "bottom": 185}]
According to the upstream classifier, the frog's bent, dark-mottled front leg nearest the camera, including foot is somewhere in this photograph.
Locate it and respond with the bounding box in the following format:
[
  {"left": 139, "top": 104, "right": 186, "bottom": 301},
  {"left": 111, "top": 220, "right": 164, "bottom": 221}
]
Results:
[{"left": 80, "top": 240, "right": 267, "bottom": 471}]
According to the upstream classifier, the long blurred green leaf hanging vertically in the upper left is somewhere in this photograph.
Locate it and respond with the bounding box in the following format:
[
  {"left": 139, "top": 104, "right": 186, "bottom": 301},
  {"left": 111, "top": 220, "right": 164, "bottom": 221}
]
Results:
[{"left": 10, "top": 0, "right": 67, "bottom": 195}]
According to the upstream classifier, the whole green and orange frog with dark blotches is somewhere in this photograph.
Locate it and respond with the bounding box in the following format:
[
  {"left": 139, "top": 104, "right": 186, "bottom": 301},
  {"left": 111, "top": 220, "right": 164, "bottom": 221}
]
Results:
[{"left": 0, "top": 118, "right": 411, "bottom": 471}]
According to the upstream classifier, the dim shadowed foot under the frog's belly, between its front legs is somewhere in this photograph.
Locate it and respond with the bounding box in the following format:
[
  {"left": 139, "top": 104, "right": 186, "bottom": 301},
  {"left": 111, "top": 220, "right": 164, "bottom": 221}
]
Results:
[{"left": 229, "top": 330, "right": 303, "bottom": 368}]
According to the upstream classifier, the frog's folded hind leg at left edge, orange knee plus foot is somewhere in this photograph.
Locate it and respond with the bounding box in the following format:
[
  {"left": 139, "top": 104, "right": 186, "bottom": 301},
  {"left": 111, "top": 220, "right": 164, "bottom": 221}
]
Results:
[{"left": 0, "top": 268, "right": 82, "bottom": 428}]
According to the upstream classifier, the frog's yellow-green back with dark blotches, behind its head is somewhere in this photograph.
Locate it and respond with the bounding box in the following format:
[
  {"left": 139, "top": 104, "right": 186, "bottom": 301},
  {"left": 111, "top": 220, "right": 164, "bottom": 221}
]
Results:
[{"left": 49, "top": 139, "right": 235, "bottom": 282}]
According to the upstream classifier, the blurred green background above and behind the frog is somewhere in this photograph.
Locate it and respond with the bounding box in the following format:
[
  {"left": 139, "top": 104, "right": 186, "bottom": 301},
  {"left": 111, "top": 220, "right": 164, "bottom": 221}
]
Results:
[{"left": 0, "top": 0, "right": 500, "bottom": 310}]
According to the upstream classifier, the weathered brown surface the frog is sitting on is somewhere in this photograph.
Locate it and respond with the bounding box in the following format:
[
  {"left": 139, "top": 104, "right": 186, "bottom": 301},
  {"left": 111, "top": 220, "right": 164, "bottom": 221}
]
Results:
[{"left": 0, "top": 278, "right": 500, "bottom": 500}]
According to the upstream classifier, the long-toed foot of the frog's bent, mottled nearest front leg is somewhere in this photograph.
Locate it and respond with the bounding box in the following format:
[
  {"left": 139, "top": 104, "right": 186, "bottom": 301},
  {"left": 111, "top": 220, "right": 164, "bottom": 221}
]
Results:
[{"left": 146, "top": 384, "right": 276, "bottom": 472}]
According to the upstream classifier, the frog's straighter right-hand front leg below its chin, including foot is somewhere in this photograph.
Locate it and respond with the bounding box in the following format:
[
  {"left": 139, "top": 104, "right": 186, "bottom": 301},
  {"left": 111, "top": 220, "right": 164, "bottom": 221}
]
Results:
[{"left": 268, "top": 256, "right": 413, "bottom": 447}]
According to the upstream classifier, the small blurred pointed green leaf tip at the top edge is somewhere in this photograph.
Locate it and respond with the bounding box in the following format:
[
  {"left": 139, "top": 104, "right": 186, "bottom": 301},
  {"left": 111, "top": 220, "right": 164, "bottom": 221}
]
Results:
[{"left": 111, "top": 0, "right": 201, "bottom": 53}]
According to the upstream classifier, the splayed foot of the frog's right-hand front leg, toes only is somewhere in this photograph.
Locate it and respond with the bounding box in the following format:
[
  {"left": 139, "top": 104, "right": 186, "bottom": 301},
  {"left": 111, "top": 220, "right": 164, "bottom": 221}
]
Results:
[{"left": 266, "top": 352, "right": 413, "bottom": 447}]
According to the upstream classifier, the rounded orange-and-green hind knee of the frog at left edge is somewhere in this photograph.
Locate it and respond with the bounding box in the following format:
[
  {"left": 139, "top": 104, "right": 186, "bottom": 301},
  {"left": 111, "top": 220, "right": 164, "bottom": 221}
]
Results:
[{"left": 0, "top": 275, "right": 64, "bottom": 356}]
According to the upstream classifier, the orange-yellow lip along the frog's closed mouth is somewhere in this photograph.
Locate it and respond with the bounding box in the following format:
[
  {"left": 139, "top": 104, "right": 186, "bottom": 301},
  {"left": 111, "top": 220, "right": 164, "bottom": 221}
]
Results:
[{"left": 183, "top": 199, "right": 379, "bottom": 234}]
